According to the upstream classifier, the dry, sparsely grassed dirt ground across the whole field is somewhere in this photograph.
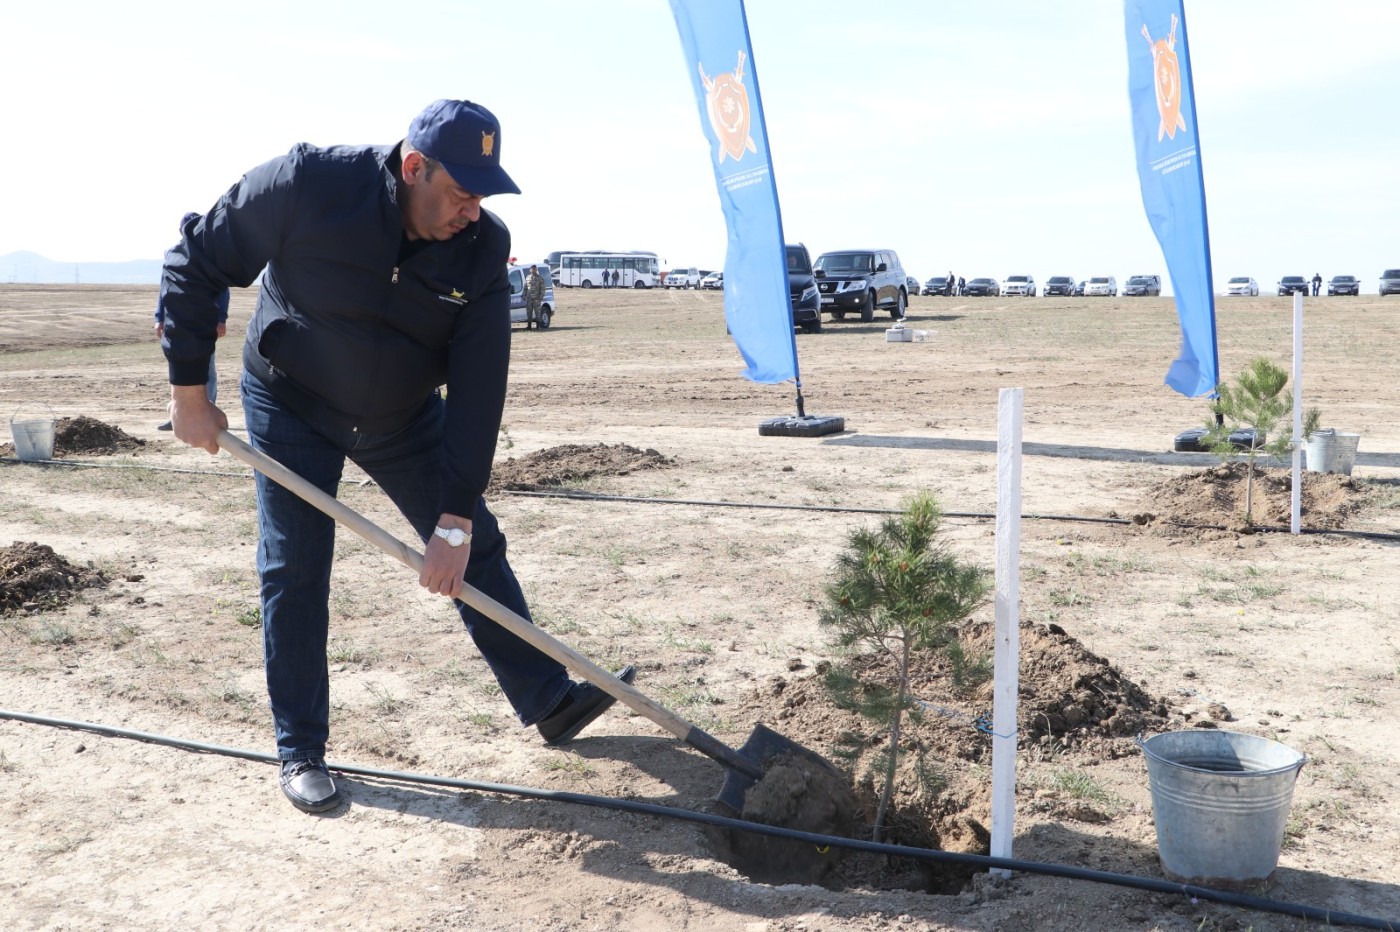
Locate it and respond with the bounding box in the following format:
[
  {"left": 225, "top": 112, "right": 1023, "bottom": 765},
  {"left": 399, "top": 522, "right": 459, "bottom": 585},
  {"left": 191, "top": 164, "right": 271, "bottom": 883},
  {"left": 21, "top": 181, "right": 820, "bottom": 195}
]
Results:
[{"left": 0, "top": 285, "right": 1400, "bottom": 932}]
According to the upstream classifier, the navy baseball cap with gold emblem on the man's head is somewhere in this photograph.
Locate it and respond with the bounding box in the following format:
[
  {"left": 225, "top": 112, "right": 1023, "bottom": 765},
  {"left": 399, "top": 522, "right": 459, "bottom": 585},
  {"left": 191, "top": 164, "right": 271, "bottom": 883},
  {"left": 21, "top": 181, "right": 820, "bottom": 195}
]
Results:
[{"left": 409, "top": 101, "right": 521, "bottom": 197}]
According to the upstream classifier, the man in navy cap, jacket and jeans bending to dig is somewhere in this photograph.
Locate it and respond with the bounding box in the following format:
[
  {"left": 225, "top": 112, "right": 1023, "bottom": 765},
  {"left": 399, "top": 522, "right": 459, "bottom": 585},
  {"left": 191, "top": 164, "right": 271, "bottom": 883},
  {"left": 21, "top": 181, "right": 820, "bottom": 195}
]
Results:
[{"left": 161, "top": 101, "right": 634, "bottom": 812}]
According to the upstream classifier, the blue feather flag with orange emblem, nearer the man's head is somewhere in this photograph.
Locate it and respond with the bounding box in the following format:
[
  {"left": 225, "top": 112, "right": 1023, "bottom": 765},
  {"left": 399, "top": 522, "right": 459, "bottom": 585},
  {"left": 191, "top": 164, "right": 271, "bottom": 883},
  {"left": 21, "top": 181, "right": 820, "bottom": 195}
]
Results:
[{"left": 671, "top": 0, "right": 798, "bottom": 382}]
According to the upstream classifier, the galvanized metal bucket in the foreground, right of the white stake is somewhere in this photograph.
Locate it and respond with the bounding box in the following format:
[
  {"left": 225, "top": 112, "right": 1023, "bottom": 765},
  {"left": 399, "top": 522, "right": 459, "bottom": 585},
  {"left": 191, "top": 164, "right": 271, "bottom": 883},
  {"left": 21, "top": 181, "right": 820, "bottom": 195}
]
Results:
[{"left": 1138, "top": 729, "right": 1308, "bottom": 890}]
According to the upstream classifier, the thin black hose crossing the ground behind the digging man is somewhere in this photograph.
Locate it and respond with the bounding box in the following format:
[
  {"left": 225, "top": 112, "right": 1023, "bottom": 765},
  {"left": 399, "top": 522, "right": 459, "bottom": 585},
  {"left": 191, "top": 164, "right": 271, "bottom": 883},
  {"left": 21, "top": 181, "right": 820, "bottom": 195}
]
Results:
[{"left": 8, "top": 456, "right": 1400, "bottom": 542}]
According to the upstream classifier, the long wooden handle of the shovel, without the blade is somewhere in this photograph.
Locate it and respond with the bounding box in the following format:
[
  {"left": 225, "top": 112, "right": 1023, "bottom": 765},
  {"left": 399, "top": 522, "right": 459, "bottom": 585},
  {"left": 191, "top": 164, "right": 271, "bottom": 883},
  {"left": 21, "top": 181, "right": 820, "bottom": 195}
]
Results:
[{"left": 218, "top": 430, "right": 760, "bottom": 777}]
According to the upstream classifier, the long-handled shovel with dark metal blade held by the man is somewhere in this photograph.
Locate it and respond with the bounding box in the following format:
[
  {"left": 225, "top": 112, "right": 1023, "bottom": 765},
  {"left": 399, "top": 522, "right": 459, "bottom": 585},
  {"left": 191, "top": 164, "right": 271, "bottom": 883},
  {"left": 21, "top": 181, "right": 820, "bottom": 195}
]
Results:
[{"left": 218, "top": 430, "right": 837, "bottom": 813}]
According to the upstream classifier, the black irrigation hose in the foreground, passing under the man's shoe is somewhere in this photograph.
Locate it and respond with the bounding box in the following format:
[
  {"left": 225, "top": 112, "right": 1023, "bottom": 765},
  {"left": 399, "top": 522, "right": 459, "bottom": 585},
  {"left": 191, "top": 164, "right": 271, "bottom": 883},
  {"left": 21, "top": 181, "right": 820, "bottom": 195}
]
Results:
[{"left": 0, "top": 709, "right": 1400, "bottom": 932}]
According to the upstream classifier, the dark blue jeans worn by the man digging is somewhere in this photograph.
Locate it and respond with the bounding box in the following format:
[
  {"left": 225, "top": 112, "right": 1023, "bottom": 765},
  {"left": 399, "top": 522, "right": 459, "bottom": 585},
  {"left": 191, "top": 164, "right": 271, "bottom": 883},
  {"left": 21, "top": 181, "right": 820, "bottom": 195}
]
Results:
[{"left": 242, "top": 372, "right": 575, "bottom": 760}]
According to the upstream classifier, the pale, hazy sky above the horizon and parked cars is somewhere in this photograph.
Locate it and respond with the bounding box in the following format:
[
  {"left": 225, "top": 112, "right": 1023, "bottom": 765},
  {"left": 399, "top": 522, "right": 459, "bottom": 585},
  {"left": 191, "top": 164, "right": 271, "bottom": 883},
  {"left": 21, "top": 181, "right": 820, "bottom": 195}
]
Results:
[{"left": 0, "top": 0, "right": 1400, "bottom": 292}]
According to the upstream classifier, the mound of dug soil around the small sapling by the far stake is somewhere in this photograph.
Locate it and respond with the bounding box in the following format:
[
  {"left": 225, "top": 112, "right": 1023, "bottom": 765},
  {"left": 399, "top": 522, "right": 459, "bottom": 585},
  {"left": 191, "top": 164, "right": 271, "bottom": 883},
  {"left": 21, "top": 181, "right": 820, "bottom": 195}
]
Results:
[{"left": 1134, "top": 463, "right": 1369, "bottom": 529}]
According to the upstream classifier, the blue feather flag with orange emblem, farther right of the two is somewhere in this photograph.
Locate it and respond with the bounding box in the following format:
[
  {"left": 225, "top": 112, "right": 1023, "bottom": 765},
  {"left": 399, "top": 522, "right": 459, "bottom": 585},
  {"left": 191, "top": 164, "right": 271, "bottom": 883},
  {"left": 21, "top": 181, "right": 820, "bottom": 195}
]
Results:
[{"left": 1123, "top": 0, "right": 1219, "bottom": 397}]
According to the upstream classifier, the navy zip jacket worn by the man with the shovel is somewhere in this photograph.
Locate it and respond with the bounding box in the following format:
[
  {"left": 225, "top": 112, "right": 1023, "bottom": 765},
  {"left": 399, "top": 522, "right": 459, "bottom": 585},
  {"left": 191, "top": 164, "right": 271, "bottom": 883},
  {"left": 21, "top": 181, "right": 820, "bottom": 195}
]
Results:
[{"left": 161, "top": 144, "right": 511, "bottom": 518}]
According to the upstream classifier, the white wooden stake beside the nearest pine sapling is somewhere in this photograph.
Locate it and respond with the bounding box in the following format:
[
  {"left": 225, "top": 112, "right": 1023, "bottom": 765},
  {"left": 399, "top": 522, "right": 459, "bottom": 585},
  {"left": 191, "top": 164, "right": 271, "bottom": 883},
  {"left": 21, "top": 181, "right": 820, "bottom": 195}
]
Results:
[{"left": 991, "top": 389, "right": 1025, "bottom": 877}]
